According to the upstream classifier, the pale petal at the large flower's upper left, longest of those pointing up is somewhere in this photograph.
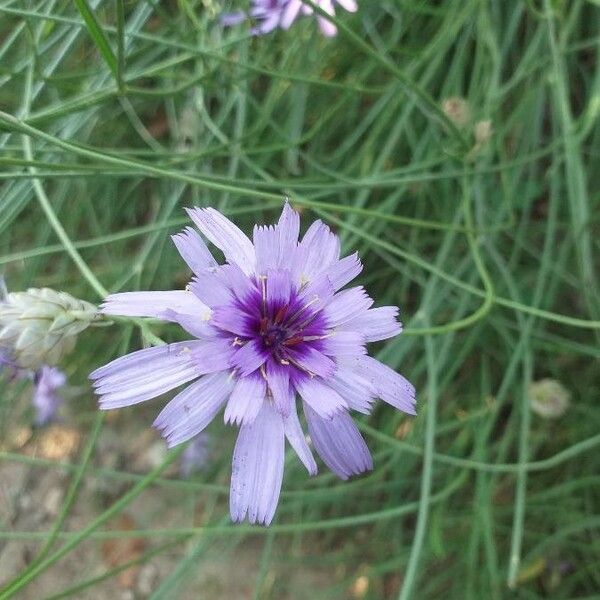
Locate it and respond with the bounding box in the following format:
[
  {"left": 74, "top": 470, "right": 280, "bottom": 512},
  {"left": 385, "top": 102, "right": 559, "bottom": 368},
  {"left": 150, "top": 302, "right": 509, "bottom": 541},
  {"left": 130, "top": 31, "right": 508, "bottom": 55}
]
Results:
[{"left": 187, "top": 208, "right": 256, "bottom": 275}]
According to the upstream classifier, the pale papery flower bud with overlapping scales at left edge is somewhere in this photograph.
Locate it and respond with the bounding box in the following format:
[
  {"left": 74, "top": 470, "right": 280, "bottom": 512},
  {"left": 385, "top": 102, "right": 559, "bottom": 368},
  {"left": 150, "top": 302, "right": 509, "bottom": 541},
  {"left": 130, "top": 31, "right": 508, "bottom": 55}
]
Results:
[{"left": 0, "top": 288, "right": 98, "bottom": 369}]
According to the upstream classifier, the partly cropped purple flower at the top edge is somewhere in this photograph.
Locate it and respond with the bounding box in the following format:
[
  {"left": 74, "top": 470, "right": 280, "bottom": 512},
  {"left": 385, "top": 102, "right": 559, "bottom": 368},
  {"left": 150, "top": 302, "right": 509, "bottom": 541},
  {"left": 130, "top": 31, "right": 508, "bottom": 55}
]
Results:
[{"left": 221, "top": 0, "right": 358, "bottom": 37}]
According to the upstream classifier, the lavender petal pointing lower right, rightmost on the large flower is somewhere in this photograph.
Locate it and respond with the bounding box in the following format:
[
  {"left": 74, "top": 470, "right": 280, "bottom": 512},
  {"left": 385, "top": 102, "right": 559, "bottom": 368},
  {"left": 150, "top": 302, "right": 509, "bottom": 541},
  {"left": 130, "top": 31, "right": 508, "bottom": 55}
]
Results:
[{"left": 348, "top": 356, "right": 416, "bottom": 415}]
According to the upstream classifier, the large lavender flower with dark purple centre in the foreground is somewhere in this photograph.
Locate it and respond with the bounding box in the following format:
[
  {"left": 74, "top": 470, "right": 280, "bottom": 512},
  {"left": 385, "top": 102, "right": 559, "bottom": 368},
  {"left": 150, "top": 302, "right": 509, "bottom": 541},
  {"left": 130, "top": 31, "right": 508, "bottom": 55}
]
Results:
[{"left": 90, "top": 203, "right": 415, "bottom": 524}]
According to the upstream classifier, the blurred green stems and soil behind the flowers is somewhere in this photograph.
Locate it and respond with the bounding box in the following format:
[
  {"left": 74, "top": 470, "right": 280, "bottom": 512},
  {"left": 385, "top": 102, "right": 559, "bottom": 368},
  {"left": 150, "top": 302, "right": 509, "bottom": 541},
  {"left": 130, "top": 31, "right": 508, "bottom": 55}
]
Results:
[{"left": 0, "top": 0, "right": 600, "bottom": 600}]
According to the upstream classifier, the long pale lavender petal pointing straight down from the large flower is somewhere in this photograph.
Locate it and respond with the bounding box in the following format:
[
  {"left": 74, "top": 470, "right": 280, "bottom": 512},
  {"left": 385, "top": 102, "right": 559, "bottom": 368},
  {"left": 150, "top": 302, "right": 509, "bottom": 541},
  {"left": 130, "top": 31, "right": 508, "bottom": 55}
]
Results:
[{"left": 229, "top": 402, "right": 285, "bottom": 525}]
